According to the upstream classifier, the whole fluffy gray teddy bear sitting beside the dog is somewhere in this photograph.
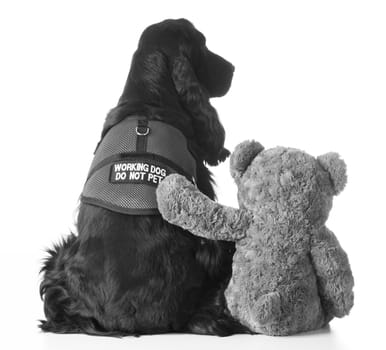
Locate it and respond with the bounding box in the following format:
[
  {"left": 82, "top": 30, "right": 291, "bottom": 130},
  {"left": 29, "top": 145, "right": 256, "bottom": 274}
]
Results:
[{"left": 157, "top": 141, "right": 354, "bottom": 335}]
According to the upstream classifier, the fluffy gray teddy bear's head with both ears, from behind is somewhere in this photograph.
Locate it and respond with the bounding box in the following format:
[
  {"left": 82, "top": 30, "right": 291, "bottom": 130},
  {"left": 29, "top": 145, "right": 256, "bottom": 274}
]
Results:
[{"left": 230, "top": 141, "right": 347, "bottom": 226}]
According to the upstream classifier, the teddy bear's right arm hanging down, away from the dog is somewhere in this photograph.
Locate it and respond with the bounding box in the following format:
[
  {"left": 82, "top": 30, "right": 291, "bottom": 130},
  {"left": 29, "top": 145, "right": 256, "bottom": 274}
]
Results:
[{"left": 311, "top": 226, "right": 354, "bottom": 317}]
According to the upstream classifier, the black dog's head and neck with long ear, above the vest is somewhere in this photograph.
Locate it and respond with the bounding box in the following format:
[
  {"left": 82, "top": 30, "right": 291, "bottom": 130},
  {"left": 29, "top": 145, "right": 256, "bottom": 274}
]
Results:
[{"left": 102, "top": 19, "right": 234, "bottom": 165}]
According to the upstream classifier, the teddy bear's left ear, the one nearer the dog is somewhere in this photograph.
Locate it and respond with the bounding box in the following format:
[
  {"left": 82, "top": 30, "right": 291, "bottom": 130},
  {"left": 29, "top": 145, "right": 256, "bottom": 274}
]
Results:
[{"left": 230, "top": 140, "right": 264, "bottom": 182}]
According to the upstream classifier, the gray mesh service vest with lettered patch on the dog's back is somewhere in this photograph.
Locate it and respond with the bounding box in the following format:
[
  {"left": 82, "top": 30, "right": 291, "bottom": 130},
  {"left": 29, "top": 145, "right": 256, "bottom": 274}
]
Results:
[{"left": 81, "top": 116, "right": 196, "bottom": 215}]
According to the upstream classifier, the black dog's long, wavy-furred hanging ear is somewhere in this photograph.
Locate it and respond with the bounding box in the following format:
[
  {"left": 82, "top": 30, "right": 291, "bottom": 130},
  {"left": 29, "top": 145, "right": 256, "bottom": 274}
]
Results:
[{"left": 172, "top": 53, "right": 230, "bottom": 165}]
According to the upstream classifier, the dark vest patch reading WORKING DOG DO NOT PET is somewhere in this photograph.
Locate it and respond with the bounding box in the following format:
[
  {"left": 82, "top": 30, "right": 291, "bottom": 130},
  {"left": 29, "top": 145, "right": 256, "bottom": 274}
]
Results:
[{"left": 110, "top": 161, "right": 170, "bottom": 186}]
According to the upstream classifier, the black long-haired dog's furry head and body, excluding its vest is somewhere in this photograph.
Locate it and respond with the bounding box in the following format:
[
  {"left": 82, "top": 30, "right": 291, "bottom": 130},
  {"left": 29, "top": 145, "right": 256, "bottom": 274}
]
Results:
[{"left": 40, "top": 19, "right": 249, "bottom": 336}]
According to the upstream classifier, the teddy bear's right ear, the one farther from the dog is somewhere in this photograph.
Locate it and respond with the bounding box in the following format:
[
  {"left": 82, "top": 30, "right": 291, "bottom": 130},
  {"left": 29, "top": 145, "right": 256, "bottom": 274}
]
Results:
[{"left": 317, "top": 152, "right": 347, "bottom": 195}]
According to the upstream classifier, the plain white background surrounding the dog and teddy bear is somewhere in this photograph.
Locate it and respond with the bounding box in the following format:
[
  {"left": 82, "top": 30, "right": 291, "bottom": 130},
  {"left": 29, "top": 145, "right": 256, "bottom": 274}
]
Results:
[{"left": 0, "top": 0, "right": 386, "bottom": 350}]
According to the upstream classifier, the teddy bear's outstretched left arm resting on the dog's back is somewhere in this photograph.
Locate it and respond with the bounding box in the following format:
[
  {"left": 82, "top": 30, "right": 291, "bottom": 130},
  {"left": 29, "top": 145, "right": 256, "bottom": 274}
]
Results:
[{"left": 157, "top": 174, "right": 253, "bottom": 241}]
